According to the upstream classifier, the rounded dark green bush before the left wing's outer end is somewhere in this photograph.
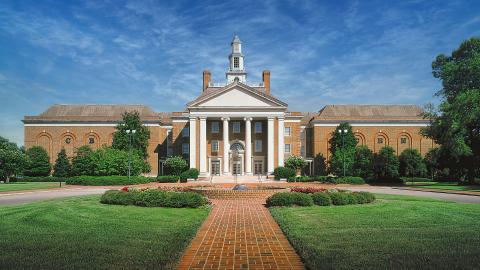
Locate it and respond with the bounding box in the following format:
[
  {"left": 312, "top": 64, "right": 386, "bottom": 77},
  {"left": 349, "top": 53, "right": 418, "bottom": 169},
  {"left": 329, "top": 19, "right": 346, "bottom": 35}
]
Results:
[{"left": 23, "top": 146, "right": 52, "bottom": 176}]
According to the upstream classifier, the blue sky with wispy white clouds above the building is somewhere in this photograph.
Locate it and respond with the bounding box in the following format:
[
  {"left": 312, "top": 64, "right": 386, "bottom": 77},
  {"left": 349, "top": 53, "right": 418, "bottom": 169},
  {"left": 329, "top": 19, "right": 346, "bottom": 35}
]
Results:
[{"left": 0, "top": 0, "right": 480, "bottom": 144}]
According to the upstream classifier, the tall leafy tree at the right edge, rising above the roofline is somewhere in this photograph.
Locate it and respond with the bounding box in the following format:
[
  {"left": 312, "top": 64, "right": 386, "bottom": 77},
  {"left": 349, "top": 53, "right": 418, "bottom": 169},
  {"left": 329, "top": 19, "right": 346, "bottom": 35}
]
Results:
[{"left": 422, "top": 38, "right": 480, "bottom": 183}]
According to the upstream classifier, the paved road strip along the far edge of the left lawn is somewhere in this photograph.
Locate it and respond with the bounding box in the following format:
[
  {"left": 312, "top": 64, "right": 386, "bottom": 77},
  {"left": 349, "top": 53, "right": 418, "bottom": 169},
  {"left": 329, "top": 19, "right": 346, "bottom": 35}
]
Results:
[{"left": 0, "top": 187, "right": 108, "bottom": 205}]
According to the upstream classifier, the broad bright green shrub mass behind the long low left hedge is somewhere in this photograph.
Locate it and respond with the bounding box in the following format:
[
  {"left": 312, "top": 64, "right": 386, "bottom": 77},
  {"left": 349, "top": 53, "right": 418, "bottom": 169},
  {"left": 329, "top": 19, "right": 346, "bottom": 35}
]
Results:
[{"left": 91, "top": 146, "right": 150, "bottom": 176}]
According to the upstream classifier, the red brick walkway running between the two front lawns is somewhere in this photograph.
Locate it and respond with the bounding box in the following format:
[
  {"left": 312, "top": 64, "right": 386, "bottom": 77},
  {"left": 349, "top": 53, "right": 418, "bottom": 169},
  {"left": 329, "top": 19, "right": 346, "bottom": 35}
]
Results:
[{"left": 178, "top": 199, "right": 304, "bottom": 269}]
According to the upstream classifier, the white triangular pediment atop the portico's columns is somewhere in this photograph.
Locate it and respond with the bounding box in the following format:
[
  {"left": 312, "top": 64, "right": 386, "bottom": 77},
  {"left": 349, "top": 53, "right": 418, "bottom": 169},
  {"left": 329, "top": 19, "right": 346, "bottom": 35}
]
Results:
[{"left": 190, "top": 83, "right": 286, "bottom": 108}]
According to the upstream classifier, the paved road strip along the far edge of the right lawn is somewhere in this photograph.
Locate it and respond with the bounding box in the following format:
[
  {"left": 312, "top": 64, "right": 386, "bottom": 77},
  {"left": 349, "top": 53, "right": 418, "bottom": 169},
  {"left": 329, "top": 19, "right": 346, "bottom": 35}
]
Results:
[{"left": 347, "top": 186, "right": 480, "bottom": 203}]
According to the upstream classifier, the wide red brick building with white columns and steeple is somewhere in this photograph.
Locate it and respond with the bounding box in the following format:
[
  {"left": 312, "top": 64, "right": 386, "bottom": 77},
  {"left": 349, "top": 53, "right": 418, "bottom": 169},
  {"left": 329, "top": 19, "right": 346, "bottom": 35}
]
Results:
[{"left": 23, "top": 36, "right": 433, "bottom": 176}]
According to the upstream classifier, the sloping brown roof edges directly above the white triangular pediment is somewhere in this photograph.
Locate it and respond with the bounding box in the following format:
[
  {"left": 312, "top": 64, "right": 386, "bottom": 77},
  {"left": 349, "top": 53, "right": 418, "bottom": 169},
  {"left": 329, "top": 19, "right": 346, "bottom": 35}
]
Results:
[{"left": 187, "top": 82, "right": 288, "bottom": 107}]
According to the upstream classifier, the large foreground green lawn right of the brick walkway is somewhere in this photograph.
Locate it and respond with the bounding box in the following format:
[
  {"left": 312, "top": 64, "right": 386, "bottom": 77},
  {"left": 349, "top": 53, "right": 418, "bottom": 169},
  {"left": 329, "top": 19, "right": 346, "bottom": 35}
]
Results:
[{"left": 270, "top": 195, "right": 480, "bottom": 269}]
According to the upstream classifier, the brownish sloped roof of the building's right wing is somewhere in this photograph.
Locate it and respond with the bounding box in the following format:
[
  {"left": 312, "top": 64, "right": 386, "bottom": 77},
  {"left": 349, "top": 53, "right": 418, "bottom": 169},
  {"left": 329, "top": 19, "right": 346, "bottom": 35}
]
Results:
[{"left": 315, "top": 105, "right": 424, "bottom": 121}]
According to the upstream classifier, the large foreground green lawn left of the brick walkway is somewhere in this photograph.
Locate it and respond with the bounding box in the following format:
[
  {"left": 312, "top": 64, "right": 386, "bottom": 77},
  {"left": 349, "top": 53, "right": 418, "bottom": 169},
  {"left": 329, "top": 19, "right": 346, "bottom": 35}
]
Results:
[{"left": 0, "top": 196, "right": 209, "bottom": 269}]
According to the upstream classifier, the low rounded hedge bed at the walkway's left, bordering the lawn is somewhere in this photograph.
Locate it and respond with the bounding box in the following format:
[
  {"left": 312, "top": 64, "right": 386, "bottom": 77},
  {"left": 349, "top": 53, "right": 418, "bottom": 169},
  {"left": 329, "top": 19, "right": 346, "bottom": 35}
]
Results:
[{"left": 100, "top": 189, "right": 208, "bottom": 208}]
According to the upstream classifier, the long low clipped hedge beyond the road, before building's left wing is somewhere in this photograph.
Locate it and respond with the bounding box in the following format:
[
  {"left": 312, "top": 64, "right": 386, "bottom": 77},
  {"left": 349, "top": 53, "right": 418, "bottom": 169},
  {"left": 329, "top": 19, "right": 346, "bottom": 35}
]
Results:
[{"left": 66, "top": 176, "right": 155, "bottom": 186}]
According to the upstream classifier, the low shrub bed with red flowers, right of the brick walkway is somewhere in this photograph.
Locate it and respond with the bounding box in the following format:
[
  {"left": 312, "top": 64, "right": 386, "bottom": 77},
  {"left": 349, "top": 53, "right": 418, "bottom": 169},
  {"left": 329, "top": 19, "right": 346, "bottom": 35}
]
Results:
[{"left": 267, "top": 187, "right": 375, "bottom": 207}]
